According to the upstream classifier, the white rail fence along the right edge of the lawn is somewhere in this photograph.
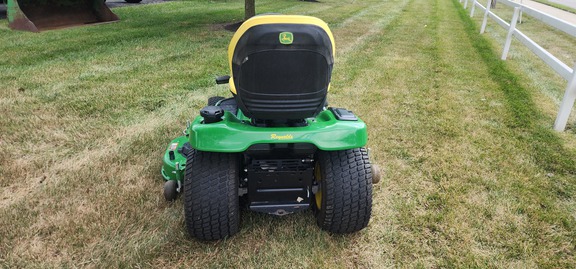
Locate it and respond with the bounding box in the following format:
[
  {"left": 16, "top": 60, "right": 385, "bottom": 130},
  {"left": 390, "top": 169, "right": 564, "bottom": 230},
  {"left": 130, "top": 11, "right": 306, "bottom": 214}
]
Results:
[{"left": 460, "top": 0, "right": 576, "bottom": 131}]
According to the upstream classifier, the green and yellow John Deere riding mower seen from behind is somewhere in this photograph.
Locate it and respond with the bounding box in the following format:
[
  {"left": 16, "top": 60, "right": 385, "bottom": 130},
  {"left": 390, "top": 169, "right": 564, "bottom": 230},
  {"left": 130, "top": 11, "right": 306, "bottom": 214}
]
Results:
[{"left": 162, "top": 15, "right": 379, "bottom": 240}]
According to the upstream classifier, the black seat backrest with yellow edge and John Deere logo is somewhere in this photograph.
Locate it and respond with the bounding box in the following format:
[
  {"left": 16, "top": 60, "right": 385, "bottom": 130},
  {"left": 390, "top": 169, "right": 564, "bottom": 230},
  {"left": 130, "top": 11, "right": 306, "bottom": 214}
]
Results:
[{"left": 228, "top": 15, "right": 334, "bottom": 120}]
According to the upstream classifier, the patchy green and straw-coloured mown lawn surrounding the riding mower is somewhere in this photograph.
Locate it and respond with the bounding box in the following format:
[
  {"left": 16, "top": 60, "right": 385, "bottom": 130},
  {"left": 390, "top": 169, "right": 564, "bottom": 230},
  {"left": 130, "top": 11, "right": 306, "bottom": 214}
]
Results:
[{"left": 0, "top": 0, "right": 576, "bottom": 268}]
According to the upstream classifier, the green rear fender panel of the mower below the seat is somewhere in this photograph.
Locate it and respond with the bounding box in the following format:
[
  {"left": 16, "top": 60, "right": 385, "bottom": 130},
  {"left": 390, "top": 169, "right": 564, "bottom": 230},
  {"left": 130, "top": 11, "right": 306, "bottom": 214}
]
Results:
[{"left": 188, "top": 110, "right": 368, "bottom": 152}]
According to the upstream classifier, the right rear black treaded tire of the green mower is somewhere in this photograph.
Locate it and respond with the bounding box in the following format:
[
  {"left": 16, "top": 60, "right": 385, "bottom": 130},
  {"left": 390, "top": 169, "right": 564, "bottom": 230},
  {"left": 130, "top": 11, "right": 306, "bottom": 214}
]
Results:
[{"left": 313, "top": 148, "right": 372, "bottom": 233}]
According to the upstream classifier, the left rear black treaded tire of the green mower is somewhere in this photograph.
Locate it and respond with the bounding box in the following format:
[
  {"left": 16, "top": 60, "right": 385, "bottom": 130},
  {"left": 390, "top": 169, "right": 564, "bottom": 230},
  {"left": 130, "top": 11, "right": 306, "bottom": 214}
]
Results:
[{"left": 184, "top": 151, "right": 240, "bottom": 240}]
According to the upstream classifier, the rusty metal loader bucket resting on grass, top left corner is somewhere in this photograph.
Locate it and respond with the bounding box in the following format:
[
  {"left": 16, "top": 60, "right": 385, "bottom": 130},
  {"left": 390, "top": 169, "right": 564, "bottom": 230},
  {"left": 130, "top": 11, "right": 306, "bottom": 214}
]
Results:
[{"left": 7, "top": 0, "right": 119, "bottom": 32}]
